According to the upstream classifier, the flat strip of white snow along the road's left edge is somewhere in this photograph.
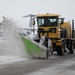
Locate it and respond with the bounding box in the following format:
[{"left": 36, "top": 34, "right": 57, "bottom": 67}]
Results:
[{"left": 0, "top": 55, "right": 28, "bottom": 65}]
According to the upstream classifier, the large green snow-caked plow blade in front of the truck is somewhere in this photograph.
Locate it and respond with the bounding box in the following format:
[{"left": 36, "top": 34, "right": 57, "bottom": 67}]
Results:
[{"left": 22, "top": 36, "right": 47, "bottom": 59}]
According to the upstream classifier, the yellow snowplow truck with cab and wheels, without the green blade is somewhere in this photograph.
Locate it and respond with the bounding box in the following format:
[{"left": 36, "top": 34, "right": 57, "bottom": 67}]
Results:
[{"left": 36, "top": 13, "right": 74, "bottom": 55}]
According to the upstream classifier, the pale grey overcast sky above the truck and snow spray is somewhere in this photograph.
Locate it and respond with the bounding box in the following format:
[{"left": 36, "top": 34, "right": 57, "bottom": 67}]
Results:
[{"left": 0, "top": 0, "right": 75, "bottom": 27}]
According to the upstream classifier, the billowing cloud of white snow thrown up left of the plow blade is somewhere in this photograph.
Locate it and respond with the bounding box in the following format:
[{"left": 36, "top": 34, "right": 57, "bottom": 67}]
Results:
[{"left": 0, "top": 17, "right": 28, "bottom": 62}]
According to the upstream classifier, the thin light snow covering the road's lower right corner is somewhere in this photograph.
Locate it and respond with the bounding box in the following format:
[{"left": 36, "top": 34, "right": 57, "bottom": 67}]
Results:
[{"left": 27, "top": 57, "right": 75, "bottom": 75}]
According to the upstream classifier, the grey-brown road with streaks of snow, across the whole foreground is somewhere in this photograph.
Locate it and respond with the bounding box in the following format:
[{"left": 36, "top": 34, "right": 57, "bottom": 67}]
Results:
[{"left": 0, "top": 54, "right": 75, "bottom": 75}]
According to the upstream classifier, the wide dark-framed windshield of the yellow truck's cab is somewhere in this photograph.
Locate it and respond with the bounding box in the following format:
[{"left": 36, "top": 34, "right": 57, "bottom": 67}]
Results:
[{"left": 37, "top": 17, "right": 58, "bottom": 26}]
